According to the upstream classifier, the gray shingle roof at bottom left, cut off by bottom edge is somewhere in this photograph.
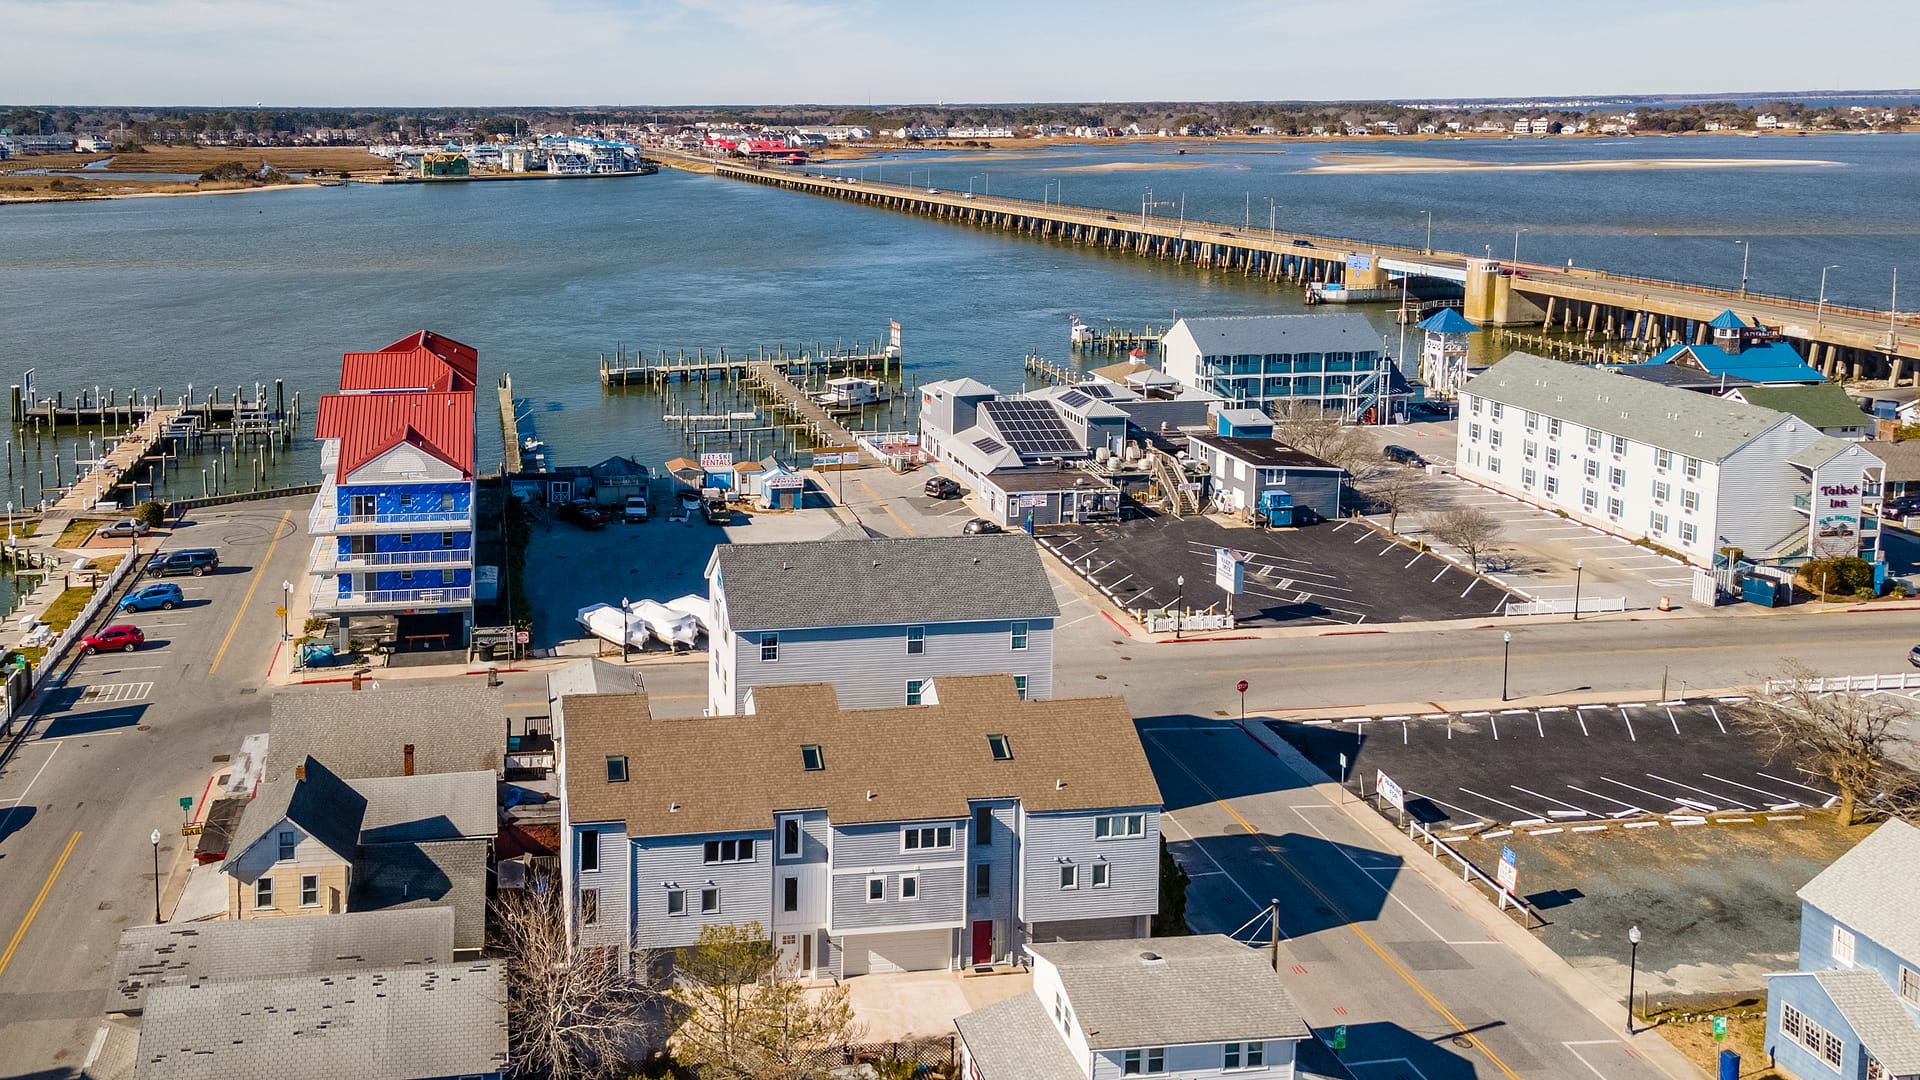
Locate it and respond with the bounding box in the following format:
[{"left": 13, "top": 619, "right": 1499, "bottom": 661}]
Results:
[{"left": 134, "top": 961, "right": 507, "bottom": 1080}]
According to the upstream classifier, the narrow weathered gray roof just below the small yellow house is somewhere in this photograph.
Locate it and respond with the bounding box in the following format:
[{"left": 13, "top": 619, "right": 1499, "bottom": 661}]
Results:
[{"left": 108, "top": 907, "right": 453, "bottom": 1013}]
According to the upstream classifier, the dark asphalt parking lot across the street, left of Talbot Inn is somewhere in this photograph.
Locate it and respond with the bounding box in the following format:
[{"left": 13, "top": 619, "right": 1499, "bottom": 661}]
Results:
[{"left": 1039, "top": 515, "right": 1511, "bottom": 626}]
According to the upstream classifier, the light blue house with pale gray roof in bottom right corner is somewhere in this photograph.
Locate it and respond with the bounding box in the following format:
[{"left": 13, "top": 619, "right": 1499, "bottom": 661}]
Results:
[{"left": 1766, "top": 819, "right": 1920, "bottom": 1080}]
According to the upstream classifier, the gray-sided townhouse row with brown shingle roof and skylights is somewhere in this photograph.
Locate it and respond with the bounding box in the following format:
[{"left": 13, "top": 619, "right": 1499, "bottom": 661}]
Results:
[{"left": 555, "top": 675, "right": 1160, "bottom": 978}]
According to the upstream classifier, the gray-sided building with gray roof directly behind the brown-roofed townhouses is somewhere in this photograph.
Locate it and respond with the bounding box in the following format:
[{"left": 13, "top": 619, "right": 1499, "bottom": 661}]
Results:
[{"left": 707, "top": 534, "right": 1060, "bottom": 717}]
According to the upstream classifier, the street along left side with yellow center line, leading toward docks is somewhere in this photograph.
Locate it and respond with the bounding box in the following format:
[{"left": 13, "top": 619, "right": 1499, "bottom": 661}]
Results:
[{"left": 0, "top": 500, "right": 307, "bottom": 1076}]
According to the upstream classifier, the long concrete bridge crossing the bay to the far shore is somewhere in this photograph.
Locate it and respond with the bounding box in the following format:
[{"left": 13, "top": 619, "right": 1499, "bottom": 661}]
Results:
[{"left": 651, "top": 150, "right": 1920, "bottom": 384}]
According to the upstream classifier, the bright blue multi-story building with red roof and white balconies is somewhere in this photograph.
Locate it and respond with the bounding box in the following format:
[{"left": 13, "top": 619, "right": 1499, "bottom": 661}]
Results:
[{"left": 307, "top": 331, "right": 474, "bottom": 651}]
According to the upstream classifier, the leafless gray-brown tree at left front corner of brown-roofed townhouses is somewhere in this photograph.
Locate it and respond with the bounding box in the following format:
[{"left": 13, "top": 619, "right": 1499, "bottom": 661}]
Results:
[{"left": 493, "top": 884, "right": 651, "bottom": 1078}]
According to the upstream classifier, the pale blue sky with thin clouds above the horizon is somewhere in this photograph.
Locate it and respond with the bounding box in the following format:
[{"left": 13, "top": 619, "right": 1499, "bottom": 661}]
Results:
[{"left": 0, "top": 0, "right": 1920, "bottom": 108}]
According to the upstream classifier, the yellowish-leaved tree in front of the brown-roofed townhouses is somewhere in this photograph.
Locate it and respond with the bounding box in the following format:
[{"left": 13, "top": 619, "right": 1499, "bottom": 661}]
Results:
[{"left": 668, "top": 922, "right": 858, "bottom": 1080}]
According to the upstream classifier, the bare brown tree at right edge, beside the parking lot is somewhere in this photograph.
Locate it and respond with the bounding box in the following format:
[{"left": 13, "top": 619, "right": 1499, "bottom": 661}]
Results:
[{"left": 1734, "top": 661, "right": 1920, "bottom": 824}]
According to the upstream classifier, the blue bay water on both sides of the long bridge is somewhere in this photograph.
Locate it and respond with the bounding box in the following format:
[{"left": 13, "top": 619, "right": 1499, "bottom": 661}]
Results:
[{"left": 0, "top": 136, "right": 1920, "bottom": 502}]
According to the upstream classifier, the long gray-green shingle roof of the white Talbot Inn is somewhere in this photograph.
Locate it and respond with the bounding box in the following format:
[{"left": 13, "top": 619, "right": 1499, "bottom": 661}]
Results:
[{"left": 1461, "top": 352, "right": 1788, "bottom": 461}]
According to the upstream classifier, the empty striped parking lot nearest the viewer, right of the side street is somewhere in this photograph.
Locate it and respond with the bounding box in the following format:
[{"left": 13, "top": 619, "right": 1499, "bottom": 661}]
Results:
[{"left": 1269, "top": 700, "right": 1836, "bottom": 832}]
